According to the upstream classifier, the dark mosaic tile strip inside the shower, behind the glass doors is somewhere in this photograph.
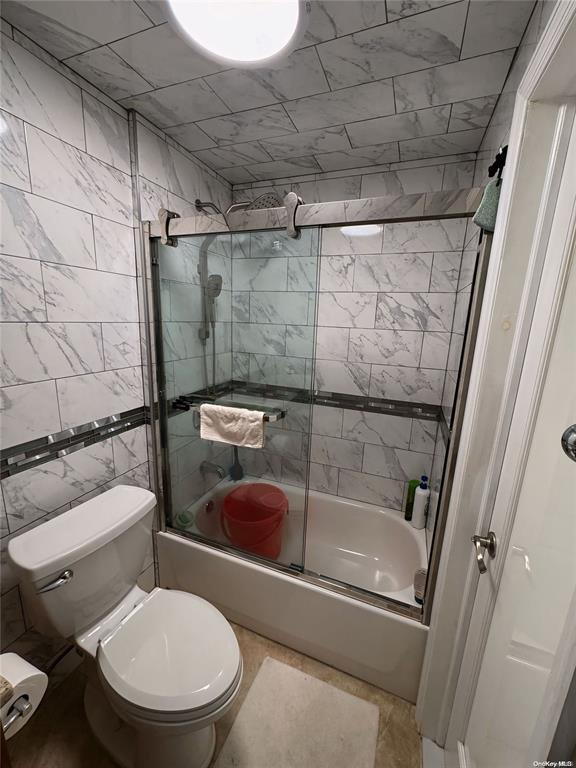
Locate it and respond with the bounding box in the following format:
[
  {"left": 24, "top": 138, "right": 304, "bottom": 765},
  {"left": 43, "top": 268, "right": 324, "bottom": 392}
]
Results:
[{"left": 168, "top": 379, "right": 443, "bottom": 421}]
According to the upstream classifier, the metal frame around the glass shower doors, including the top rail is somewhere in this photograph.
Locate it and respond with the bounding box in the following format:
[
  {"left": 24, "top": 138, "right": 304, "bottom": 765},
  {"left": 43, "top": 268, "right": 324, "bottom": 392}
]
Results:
[{"left": 141, "top": 188, "right": 490, "bottom": 626}]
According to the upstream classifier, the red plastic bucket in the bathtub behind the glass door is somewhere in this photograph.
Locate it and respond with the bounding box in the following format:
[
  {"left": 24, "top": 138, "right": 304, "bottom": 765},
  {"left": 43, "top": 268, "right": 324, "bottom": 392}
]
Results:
[{"left": 222, "top": 483, "right": 288, "bottom": 559}]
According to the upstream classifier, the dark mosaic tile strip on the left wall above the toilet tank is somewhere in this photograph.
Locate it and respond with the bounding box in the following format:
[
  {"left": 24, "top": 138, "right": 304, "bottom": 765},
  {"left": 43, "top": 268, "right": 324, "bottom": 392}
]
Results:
[{"left": 0, "top": 406, "right": 150, "bottom": 479}]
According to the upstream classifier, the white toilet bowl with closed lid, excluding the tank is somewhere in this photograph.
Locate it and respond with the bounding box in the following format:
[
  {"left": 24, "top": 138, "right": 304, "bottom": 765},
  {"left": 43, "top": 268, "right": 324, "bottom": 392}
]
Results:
[{"left": 83, "top": 588, "right": 242, "bottom": 768}]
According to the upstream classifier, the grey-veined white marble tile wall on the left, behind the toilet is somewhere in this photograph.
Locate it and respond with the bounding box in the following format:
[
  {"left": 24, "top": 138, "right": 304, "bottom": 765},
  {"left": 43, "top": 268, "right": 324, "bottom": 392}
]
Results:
[{"left": 0, "top": 31, "right": 231, "bottom": 656}]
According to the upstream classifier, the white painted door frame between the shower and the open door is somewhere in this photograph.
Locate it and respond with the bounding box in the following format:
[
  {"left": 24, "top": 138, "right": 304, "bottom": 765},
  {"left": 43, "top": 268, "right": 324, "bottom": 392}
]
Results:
[{"left": 416, "top": 0, "right": 576, "bottom": 765}]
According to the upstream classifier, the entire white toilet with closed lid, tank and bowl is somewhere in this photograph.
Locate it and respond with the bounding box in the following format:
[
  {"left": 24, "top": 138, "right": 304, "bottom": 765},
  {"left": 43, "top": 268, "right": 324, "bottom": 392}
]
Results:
[{"left": 8, "top": 486, "right": 242, "bottom": 768}]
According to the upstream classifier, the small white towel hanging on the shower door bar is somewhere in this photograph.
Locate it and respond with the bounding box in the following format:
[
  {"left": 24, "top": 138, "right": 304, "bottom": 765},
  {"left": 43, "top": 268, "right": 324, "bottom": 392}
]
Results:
[{"left": 200, "top": 403, "right": 264, "bottom": 448}]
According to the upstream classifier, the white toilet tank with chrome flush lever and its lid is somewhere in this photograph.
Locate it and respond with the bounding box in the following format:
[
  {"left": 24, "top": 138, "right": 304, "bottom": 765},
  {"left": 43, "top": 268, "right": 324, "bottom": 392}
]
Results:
[{"left": 8, "top": 485, "right": 156, "bottom": 638}]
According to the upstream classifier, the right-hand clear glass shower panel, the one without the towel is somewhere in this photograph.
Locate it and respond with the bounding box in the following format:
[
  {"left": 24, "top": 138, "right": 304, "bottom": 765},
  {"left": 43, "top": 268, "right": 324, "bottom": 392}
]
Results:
[{"left": 305, "top": 218, "right": 476, "bottom": 615}]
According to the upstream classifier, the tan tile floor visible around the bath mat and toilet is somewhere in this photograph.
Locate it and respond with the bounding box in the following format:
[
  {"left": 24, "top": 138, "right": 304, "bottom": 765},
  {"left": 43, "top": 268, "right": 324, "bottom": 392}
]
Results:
[{"left": 9, "top": 625, "right": 421, "bottom": 768}]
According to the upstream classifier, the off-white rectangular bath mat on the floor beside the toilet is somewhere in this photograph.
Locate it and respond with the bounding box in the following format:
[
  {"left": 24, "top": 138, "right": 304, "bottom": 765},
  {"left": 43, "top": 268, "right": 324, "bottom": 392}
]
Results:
[{"left": 215, "top": 657, "right": 379, "bottom": 768}]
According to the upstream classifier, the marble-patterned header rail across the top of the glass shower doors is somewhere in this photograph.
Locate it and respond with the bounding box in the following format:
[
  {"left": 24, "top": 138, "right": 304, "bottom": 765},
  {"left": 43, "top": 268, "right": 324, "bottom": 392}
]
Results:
[{"left": 150, "top": 187, "right": 484, "bottom": 237}]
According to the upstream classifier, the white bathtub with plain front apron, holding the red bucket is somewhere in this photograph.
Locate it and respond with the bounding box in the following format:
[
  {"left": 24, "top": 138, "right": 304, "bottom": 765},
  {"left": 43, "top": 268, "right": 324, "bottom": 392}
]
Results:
[{"left": 157, "top": 478, "right": 427, "bottom": 702}]
